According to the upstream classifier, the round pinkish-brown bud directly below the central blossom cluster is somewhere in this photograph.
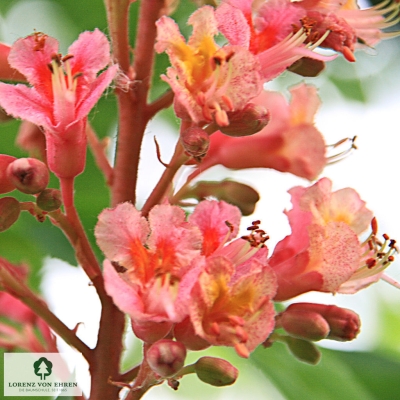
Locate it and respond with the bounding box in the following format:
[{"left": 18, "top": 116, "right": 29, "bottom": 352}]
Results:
[{"left": 146, "top": 339, "right": 186, "bottom": 378}]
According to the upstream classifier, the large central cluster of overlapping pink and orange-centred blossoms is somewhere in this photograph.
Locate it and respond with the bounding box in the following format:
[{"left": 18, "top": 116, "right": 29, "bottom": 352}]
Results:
[{"left": 95, "top": 201, "right": 276, "bottom": 357}]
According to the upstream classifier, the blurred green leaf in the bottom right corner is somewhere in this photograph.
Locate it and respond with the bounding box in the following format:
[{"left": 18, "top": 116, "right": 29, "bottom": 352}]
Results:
[{"left": 251, "top": 343, "right": 400, "bottom": 400}]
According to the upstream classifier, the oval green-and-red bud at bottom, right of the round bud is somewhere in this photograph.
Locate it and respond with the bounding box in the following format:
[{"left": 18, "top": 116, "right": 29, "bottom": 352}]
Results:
[{"left": 194, "top": 357, "right": 239, "bottom": 386}]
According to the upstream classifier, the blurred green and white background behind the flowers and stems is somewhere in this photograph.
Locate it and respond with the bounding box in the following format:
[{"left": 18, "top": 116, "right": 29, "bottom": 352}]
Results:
[{"left": 0, "top": 0, "right": 400, "bottom": 400}]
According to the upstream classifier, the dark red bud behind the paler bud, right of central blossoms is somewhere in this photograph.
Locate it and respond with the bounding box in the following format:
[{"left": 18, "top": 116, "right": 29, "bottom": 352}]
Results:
[{"left": 288, "top": 303, "right": 361, "bottom": 342}]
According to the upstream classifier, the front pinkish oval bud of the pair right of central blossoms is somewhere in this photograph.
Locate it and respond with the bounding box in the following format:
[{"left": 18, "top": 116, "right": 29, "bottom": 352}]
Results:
[{"left": 279, "top": 310, "right": 330, "bottom": 341}]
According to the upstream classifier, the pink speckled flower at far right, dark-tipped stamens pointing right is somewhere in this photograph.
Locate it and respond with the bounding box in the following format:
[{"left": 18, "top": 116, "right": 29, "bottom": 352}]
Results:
[{"left": 270, "top": 178, "right": 395, "bottom": 301}]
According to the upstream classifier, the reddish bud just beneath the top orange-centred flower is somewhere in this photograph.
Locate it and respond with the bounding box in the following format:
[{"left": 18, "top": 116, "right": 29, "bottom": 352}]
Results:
[{"left": 219, "top": 103, "right": 270, "bottom": 137}]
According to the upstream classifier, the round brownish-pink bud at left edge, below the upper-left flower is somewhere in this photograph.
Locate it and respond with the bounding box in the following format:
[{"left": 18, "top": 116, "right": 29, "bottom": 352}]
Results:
[{"left": 7, "top": 158, "right": 49, "bottom": 194}]
